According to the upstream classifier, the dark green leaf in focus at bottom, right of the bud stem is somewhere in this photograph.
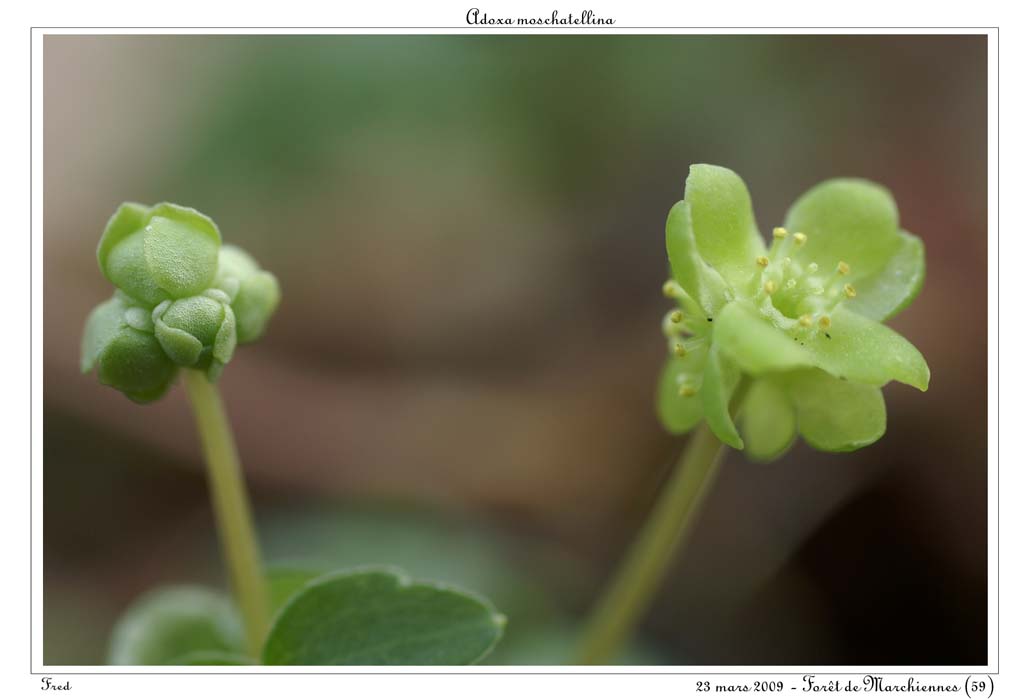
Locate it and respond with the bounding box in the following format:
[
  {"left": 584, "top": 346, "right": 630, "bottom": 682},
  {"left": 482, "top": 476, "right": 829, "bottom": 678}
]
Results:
[{"left": 262, "top": 568, "right": 505, "bottom": 666}]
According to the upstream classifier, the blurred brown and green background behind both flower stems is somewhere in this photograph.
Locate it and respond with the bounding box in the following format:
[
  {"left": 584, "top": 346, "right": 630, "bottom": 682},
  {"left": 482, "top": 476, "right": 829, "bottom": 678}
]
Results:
[{"left": 43, "top": 35, "right": 987, "bottom": 665}]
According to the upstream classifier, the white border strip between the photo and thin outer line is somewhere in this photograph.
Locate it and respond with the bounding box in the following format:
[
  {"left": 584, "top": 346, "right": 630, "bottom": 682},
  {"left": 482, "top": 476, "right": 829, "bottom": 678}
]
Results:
[{"left": 30, "top": 27, "right": 1000, "bottom": 683}]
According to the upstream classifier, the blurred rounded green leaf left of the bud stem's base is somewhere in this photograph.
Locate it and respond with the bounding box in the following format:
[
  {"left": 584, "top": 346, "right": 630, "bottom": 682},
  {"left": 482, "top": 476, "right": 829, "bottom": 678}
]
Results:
[{"left": 108, "top": 586, "right": 243, "bottom": 666}]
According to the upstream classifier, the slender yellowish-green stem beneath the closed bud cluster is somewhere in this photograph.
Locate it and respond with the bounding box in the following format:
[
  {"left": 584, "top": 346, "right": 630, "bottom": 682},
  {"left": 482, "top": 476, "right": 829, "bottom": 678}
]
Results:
[{"left": 185, "top": 370, "right": 269, "bottom": 658}]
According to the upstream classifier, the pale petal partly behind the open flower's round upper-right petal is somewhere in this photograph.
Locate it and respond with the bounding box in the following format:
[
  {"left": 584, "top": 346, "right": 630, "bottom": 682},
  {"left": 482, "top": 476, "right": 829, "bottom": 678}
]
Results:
[{"left": 847, "top": 231, "right": 925, "bottom": 321}]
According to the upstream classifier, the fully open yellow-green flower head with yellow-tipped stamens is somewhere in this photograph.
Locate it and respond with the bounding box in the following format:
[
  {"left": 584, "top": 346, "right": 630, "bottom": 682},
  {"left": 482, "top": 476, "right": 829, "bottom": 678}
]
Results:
[{"left": 658, "top": 165, "right": 929, "bottom": 459}]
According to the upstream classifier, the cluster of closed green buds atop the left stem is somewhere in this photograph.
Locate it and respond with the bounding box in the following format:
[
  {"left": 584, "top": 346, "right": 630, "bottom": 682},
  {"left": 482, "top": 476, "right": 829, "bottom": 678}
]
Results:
[{"left": 81, "top": 203, "right": 280, "bottom": 403}]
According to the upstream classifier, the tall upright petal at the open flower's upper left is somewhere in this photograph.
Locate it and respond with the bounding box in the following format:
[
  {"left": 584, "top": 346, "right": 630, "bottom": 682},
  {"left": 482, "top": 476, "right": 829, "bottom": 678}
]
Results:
[{"left": 684, "top": 165, "right": 765, "bottom": 288}]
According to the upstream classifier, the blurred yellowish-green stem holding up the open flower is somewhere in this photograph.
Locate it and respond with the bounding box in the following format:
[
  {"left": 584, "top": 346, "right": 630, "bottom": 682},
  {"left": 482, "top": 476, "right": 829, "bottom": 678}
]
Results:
[{"left": 574, "top": 379, "right": 748, "bottom": 665}]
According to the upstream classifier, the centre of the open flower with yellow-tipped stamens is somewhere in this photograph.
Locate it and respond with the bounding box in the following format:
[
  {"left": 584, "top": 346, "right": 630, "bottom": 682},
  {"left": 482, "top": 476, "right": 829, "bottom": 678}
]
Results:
[{"left": 749, "top": 226, "right": 857, "bottom": 330}]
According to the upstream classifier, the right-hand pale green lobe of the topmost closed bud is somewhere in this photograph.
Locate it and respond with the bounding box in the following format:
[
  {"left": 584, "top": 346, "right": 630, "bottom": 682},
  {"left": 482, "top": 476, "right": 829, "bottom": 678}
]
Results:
[{"left": 143, "top": 211, "right": 221, "bottom": 299}]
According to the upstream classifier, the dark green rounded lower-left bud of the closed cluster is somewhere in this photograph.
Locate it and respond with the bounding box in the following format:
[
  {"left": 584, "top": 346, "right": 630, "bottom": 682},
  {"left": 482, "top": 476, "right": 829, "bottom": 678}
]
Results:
[{"left": 97, "top": 325, "right": 177, "bottom": 404}]
